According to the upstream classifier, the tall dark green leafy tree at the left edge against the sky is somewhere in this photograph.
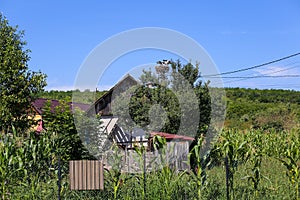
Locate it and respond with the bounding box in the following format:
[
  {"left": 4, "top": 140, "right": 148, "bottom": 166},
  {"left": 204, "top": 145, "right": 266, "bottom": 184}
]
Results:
[{"left": 0, "top": 14, "right": 46, "bottom": 132}]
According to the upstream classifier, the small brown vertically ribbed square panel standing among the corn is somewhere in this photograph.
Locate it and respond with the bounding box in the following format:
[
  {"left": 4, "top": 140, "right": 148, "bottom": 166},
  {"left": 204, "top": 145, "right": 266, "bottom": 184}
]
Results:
[{"left": 69, "top": 160, "right": 104, "bottom": 190}]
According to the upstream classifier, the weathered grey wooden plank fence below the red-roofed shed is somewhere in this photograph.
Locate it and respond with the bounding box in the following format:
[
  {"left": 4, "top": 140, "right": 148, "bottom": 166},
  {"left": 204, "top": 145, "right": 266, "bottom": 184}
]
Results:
[{"left": 103, "top": 141, "right": 190, "bottom": 173}]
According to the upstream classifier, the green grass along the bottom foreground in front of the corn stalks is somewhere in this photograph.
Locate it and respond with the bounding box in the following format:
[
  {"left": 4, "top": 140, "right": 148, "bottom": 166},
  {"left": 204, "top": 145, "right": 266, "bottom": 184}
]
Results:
[{"left": 49, "top": 157, "right": 296, "bottom": 200}]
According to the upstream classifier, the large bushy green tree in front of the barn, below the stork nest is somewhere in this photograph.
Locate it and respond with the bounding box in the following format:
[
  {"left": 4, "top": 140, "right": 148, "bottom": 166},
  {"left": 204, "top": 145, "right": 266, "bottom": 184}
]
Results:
[{"left": 112, "top": 60, "right": 211, "bottom": 137}]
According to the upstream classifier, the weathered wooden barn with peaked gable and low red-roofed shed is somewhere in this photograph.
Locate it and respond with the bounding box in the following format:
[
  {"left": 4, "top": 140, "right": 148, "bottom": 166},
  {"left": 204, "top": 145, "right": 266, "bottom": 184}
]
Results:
[{"left": 86, "top": 75, "right": 194, "bottom": 171}]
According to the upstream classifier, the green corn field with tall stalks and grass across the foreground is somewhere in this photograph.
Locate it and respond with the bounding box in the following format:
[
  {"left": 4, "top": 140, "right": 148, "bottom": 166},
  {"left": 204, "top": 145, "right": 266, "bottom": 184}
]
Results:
[{"left": 0, "top": 129, "right": 300, "bottom": 200}]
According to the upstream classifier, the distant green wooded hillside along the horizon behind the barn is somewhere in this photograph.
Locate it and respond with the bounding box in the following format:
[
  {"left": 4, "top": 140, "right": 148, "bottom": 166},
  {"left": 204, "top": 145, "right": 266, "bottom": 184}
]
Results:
[{"left": 38, "top": 88, "right": 300, "bottom": 130}]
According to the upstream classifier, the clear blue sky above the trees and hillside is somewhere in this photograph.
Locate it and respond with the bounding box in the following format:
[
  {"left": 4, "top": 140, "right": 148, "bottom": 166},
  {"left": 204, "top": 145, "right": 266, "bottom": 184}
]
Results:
[{"left": 0, "top": 0, "right": 300, "bottom": 90}]
